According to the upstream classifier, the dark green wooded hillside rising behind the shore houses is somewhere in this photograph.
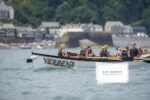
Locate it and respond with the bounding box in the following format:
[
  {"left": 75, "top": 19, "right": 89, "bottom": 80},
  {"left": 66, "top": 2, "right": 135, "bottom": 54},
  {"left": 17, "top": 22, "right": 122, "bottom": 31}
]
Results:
[{"left": 13, "top": 0, "right": 150, "bottom": 33}]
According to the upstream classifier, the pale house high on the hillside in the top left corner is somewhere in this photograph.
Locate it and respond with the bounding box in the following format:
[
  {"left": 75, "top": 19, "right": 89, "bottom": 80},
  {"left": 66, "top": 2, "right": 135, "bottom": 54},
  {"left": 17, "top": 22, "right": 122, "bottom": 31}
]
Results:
[{"left": 0, "top": 0, "right": 14, "bottom": 19}]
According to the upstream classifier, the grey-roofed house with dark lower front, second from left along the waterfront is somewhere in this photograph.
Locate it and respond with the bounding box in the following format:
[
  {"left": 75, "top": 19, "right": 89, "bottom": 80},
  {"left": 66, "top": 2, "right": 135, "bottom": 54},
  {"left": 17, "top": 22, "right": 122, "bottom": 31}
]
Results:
[{"left": 16, "top": 26, "right": 36, "bottom": 42}]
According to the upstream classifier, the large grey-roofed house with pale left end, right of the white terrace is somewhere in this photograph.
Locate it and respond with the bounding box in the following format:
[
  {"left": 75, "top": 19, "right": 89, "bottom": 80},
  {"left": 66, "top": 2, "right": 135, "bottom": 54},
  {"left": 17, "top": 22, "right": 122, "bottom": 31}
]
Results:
[{"left": 104, "top": 21, "right": 124, "bottom": 33}]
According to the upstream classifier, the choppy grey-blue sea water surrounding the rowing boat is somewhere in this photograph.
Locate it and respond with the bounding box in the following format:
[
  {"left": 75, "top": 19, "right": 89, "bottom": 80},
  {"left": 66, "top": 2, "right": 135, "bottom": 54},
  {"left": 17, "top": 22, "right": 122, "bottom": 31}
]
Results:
[{"left": 0, "top": 49, "right": 150, "bottom": 100}]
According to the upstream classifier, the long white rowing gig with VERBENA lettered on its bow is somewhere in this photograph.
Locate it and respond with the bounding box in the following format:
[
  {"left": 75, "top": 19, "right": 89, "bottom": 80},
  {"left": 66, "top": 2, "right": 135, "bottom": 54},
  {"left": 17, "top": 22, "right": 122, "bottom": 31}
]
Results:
[{"left": 27, "top": 52, "right": 150, "bottom": 68}]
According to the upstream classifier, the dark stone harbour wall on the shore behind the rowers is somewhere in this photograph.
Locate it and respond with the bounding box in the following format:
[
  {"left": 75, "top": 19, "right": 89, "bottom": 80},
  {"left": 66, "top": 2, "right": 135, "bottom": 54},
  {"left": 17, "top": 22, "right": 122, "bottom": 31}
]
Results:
[{"left": 57, "top": 32, "right": 113, "bottom": 47}]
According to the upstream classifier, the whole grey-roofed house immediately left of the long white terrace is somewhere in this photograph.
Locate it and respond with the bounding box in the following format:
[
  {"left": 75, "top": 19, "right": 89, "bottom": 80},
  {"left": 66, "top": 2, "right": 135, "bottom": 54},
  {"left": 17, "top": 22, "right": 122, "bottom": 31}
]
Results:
[{"left": 38, "top": 22, "right": 60, "bottom": 39}]
